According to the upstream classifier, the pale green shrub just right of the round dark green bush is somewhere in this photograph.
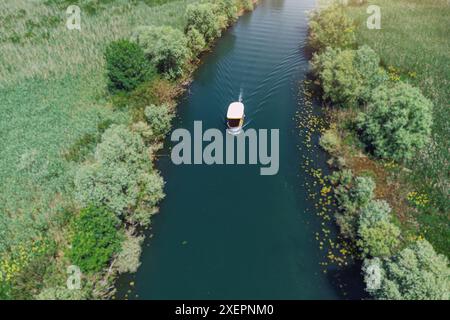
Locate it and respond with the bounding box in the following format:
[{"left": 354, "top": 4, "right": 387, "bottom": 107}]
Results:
[{"left": 132, "top": 26, "right": 190, "bottom": 78}]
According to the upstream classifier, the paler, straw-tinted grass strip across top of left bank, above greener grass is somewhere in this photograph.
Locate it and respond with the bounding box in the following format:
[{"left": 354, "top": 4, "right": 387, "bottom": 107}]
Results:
[{"left": 0, "top": 0, "right": 197, "bottom": 88}]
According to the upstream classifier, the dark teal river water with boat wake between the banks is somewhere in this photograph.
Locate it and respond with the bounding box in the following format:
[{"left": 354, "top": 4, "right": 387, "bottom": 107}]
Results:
[{"left": 119, "top": 0, "right": 366, "bottom": 299}]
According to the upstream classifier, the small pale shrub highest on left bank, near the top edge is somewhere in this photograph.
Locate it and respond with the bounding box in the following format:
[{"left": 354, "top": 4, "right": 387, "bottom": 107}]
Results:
[{"left": 186, "top": 3, "right": 223, "bottom": 43}]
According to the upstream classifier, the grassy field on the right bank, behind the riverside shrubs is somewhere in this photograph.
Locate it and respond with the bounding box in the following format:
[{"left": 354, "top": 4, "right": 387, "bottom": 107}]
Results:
[{"left": 346, "top": 0, "right": 450, "bottom": 256}]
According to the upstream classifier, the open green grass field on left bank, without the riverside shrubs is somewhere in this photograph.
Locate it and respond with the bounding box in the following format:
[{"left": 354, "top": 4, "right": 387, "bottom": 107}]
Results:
[{"left": 0, "top": 0, "right": 195, "bottom": 298}]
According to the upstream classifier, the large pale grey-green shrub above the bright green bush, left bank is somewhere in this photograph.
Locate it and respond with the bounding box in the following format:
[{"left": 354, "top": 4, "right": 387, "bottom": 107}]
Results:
[{"left": 75, "top": 125, "right": 164, "bottom": 226}]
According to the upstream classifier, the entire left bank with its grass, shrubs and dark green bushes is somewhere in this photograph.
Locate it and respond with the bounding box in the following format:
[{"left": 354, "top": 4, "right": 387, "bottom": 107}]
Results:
[{"left": 0, "top": 0, "right": 257, "bottom": 300}]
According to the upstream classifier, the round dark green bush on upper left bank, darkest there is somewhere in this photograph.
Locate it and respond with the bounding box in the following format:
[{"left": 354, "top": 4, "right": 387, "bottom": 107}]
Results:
[{"left": 105, "top": 40, "right": 154, "bottom": 92}]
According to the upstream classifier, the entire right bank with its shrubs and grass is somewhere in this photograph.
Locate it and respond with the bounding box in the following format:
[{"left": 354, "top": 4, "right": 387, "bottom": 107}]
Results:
[{"left": 306, "top": 0, "right": 450, "bottom": 300}]
